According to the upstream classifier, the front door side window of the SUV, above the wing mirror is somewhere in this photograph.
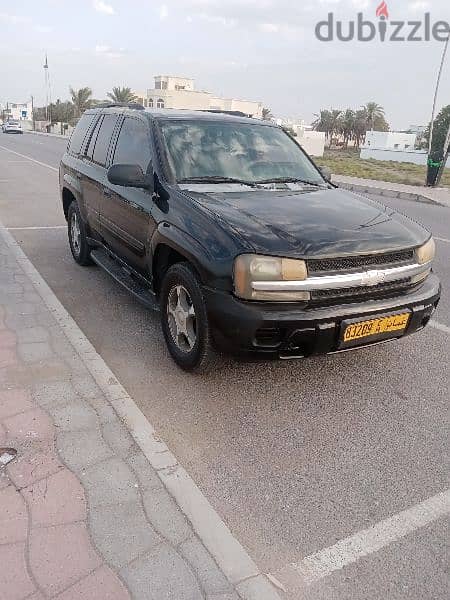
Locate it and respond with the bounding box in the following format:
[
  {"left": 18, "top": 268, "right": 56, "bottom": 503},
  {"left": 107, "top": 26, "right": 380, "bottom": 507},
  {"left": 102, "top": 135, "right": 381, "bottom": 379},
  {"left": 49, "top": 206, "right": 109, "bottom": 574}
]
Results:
[{"left": 114, "top": 118, "right": 151, "bottom": 173}]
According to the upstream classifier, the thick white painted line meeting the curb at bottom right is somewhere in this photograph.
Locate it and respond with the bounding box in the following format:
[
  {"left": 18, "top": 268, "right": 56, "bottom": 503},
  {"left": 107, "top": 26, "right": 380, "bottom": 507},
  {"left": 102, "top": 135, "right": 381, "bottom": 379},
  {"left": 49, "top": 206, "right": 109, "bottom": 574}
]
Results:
[{"left": 275, "top": 490, "right": 450, "bottom": 585}]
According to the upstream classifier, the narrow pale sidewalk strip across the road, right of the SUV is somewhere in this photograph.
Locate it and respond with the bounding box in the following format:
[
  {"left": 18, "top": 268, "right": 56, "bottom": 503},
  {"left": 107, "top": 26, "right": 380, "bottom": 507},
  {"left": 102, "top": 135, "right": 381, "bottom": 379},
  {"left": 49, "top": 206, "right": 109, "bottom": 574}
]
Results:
[{"left": 332, "top": 175, "right": 450, "bottom": 206}]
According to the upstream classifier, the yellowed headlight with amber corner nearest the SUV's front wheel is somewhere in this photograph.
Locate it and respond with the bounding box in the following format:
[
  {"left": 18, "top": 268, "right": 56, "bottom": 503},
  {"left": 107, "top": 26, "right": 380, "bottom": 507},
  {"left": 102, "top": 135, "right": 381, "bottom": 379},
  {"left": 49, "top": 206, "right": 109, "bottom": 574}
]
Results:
[{"left": 234, "top": 254, "right": 310, "bottom": 302}]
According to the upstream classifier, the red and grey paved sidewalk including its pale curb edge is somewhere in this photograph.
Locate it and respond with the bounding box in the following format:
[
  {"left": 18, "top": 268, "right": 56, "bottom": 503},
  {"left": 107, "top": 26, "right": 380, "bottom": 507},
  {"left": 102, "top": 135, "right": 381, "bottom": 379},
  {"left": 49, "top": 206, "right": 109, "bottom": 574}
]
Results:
[{"left": 0, "top": 224, "right": 278, "bottom": 600}]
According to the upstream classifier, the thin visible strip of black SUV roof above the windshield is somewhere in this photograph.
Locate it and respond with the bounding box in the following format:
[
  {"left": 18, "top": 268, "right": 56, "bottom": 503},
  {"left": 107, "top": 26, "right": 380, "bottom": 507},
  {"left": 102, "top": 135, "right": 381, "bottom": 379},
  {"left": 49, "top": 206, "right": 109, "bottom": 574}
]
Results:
[{"left": 85, "top": 106, "right": 276, "bottom": 127}]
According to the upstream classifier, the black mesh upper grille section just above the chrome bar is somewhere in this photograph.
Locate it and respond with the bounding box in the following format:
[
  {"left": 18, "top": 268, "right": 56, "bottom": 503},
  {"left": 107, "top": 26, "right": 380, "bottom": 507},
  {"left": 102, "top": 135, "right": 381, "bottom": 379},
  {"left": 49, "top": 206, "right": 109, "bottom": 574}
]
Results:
[{"left": 308, "top": 250, "right": 414, "bottom": 274}]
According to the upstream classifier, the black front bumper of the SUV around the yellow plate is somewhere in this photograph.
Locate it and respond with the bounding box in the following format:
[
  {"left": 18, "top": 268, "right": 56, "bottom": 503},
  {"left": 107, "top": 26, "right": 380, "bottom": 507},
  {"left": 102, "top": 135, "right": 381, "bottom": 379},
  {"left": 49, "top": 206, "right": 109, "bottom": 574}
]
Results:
[{"left": 204, "top": 274, "right": 441, "bottom": 358}]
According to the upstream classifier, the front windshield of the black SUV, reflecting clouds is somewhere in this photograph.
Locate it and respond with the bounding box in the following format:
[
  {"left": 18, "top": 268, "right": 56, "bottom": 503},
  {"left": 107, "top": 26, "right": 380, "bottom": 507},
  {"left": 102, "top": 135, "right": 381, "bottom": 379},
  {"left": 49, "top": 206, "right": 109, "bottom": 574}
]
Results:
[{"left": 161, "top": 120, "right": 326, "bottom": 185}]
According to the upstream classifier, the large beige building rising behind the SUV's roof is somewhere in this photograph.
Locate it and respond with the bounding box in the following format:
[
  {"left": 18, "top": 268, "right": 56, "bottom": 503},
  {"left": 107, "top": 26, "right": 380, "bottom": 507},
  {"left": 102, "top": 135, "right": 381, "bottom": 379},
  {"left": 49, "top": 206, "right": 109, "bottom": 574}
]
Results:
[{"left": 136, "top": 75, "right": 263, "bottom": 119}]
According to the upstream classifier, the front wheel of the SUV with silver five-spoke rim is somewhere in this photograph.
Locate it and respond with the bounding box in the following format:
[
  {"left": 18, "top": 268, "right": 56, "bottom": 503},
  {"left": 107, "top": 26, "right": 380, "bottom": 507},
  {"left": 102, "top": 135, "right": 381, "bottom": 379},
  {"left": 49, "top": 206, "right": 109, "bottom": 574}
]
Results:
[{"left": 160, "top": 263, "right": 215, "bottom": 372}]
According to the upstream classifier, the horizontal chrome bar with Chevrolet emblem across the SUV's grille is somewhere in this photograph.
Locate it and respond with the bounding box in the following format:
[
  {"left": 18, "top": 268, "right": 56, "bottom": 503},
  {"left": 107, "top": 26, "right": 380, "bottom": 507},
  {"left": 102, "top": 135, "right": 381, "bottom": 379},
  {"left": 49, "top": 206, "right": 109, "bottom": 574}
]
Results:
[{"left": 252, "top": 262, "right": 431, "bottom": 292}]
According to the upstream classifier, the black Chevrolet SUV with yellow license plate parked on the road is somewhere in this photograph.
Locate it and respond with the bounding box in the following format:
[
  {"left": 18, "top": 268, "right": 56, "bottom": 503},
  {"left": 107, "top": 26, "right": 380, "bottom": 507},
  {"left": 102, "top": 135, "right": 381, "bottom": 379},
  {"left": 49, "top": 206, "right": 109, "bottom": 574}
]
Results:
[{"left": 60, "top": 105, "right": 440, "bottom": 370}]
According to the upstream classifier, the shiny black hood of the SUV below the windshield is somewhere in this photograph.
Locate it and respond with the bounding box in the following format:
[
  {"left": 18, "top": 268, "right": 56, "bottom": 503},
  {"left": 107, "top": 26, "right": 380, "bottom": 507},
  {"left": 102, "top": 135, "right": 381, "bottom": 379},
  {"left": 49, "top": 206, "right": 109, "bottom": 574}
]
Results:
[{"left": 188, "top": 188, "right": 429, "bottom": 258}]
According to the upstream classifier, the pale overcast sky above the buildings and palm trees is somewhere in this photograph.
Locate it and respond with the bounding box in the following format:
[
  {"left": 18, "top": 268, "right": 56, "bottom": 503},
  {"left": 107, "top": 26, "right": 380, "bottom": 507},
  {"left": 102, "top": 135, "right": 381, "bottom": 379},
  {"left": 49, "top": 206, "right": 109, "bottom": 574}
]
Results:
[{"left": 0, "top": 0, "right": 450, "bottom": 128}]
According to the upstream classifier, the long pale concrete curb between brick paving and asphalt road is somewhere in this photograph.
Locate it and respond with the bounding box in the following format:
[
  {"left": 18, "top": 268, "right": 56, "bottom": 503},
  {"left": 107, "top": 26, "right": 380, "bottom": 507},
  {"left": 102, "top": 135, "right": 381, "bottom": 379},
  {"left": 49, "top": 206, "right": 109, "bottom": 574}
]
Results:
[{"left": 0, "top": 222, "right": 280, "bottom": 600}]
